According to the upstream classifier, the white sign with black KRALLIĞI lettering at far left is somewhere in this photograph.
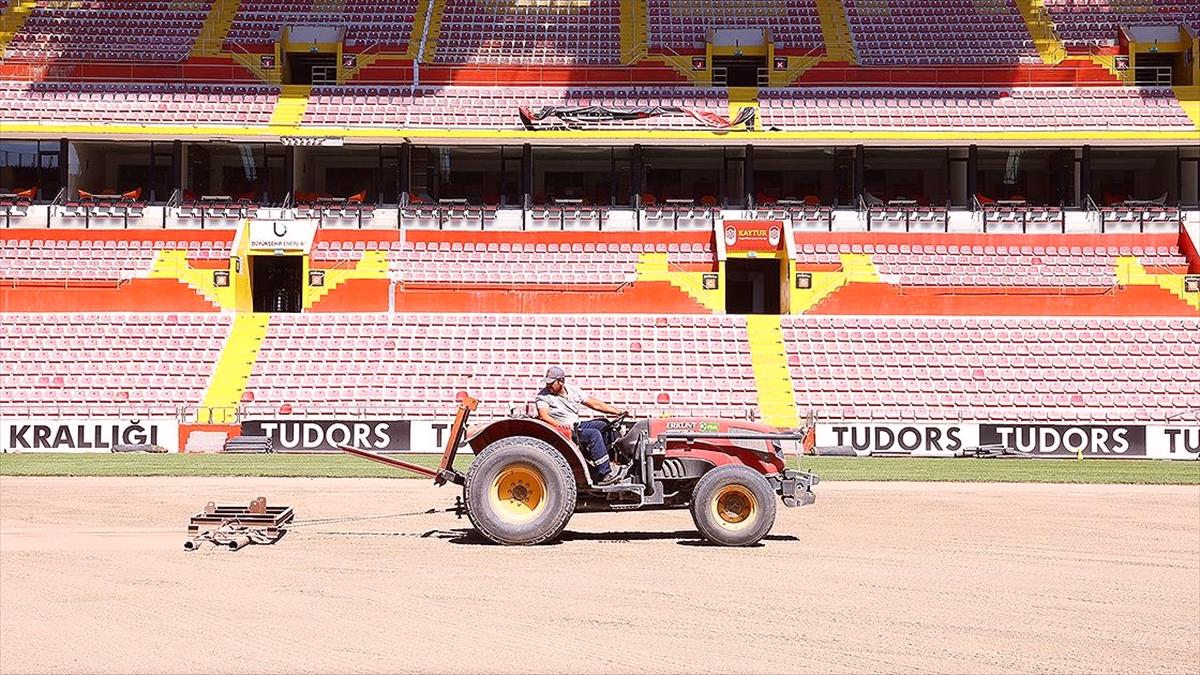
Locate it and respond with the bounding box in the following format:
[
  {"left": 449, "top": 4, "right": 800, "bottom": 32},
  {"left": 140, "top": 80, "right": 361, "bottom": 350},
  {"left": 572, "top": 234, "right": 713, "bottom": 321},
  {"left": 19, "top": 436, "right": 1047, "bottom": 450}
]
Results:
[{"left": 0, "top": 419, "right": 179, "bottom": 453}]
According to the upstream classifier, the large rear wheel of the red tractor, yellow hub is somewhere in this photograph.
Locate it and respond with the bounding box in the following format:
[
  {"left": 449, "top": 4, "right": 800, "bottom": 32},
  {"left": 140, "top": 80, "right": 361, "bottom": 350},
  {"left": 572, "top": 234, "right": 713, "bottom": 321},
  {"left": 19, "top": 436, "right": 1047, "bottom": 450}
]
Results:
[{"left": 463, "top": 436, "right": 576, "bottom": 545}]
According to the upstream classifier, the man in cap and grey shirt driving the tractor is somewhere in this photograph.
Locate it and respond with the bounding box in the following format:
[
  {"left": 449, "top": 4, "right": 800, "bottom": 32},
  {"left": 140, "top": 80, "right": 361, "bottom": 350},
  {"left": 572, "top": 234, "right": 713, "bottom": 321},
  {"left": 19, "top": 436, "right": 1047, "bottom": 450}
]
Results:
[{"left": 536, "top": 366, "right": 622, "bottom": 485}]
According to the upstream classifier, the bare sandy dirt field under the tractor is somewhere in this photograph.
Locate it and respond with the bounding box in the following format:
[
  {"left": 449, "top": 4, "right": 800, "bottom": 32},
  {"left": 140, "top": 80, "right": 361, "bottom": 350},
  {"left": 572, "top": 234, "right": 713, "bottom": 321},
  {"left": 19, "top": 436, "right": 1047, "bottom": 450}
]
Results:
[{"left": 0, "top": 477, "right": 1200, "bottom": 673}]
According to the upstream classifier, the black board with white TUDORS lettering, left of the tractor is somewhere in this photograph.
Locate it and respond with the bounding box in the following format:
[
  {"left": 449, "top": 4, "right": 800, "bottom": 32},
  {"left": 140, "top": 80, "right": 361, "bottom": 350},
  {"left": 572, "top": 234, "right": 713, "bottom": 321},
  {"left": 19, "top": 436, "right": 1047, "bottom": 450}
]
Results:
[{"left": 241, "top": 419, "right": 412, "bottom": 453}]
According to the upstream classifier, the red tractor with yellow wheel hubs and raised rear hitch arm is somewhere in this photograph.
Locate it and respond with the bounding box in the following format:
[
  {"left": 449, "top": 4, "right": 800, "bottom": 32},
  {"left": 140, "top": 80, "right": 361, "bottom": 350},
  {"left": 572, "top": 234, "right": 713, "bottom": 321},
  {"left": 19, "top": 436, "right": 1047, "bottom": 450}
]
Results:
[{"left": 342, "top": 398, "right": 820, "bottom": 546}]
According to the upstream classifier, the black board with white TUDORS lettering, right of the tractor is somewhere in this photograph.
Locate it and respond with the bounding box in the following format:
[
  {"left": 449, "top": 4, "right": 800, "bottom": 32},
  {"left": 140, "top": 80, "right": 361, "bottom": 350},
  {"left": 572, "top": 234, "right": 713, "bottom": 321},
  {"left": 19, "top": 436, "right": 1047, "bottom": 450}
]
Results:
[{"left": 979, "top": 424, "right": 1146, "bottom": 458}]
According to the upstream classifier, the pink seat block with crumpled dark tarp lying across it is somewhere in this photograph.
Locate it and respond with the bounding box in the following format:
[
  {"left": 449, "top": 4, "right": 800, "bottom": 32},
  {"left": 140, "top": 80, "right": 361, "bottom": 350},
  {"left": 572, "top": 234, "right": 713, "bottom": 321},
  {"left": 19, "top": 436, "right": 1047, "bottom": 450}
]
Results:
[{"left": 304, "top": 86, "right": 728, "bottom": 129}]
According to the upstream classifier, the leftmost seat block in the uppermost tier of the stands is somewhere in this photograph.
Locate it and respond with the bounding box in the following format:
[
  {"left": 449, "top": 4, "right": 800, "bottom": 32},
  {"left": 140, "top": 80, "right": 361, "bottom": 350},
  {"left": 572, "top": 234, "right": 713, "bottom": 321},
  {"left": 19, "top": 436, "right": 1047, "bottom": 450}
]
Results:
[{"left": 5, "top": 0, "right": 212, "bottom": 61}]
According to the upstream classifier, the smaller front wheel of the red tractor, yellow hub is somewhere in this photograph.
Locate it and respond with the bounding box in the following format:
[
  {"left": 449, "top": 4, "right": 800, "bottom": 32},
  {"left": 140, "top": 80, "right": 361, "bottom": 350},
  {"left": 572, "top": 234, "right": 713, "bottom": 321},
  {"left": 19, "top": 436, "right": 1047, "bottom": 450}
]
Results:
[{"left": 691, "top": 464, "right": 778, "bottom": 546}]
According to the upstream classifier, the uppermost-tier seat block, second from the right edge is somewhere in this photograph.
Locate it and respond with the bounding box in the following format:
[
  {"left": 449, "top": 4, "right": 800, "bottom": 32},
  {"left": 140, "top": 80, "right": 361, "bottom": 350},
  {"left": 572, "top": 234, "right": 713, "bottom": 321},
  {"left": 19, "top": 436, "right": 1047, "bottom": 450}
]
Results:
[{"left": 845, "top": 0, "right": 1037, "bottom": 65}]
